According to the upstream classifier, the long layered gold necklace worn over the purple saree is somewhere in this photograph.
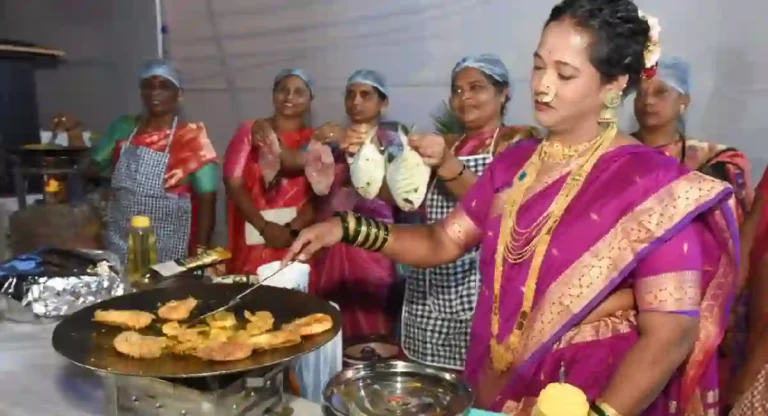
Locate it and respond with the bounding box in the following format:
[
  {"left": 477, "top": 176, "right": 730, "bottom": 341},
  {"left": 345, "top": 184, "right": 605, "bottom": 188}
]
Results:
[{"left": 490, "top": 123, "right": 617, "bottom": 373}]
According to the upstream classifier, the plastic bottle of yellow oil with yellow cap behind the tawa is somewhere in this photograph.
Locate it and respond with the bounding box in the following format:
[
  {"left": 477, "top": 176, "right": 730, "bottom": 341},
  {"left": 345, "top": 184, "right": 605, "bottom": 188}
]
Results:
[{"left": 125, "top": 215, "right": 157, "bottom": 290}]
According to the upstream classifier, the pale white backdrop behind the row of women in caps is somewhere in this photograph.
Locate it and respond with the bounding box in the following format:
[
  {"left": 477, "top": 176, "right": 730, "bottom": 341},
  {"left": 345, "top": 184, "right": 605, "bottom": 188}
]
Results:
[{"left": 163, "top": 0, "right": 768, "bottom": 244}]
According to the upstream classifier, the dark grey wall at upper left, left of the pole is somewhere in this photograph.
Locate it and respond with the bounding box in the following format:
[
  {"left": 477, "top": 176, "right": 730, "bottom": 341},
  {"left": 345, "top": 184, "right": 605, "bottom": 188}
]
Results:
[{"left": 0, "top": 0, "right": 157, "bottom": 131}]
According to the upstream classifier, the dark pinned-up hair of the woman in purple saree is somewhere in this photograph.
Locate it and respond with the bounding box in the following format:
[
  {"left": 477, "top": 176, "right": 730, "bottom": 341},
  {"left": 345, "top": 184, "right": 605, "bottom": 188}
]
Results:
[{"left": 547, "top": 0, "right": 651, "bottom": 91}]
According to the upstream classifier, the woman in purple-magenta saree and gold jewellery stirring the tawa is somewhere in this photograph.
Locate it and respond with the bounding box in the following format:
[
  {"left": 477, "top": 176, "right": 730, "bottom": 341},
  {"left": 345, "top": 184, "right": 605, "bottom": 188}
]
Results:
[{"left": 286, "top": 0, "right": 738, "bottom": 416}]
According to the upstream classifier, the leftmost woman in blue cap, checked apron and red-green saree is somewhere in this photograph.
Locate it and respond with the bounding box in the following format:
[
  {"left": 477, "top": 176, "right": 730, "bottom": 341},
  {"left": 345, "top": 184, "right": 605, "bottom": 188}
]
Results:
[{"left": 100, "top": 60, "right": 219, "bottom": 262}]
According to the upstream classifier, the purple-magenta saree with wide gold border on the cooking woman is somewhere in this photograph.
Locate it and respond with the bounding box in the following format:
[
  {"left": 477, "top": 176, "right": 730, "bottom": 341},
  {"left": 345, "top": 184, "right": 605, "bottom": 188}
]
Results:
[{"left": 459, "top": 140, "right": 738, "bottom": 416}]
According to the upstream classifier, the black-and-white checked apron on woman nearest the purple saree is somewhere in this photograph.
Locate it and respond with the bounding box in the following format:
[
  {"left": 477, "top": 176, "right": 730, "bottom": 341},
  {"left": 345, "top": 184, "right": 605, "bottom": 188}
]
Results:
[{"left": 401, "top": 130, "right": 499, "bottom": 370}]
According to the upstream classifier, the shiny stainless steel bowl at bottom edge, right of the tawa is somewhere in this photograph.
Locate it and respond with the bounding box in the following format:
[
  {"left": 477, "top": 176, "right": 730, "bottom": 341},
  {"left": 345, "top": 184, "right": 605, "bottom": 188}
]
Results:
[{"left": 323, "top": 361, "right": 474, "bottom": 416}]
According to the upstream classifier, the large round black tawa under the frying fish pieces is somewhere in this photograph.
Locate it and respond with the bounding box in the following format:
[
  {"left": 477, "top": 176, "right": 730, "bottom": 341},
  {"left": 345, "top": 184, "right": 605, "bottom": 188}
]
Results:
[{"left": 53, "top": 282, "right": 341, "bottom": 378}]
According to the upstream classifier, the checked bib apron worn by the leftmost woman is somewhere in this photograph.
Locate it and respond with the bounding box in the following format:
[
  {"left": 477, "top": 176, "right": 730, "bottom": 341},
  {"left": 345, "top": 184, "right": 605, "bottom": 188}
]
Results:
[{"left": 107, "top": 119, "right": 192, "bottom": 265}]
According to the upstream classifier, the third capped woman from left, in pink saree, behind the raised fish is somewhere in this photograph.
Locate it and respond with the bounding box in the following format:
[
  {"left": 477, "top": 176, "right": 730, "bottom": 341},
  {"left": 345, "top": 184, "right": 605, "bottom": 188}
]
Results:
[{"left": 254, "top": 69, "right": 402, "bottom": 345}]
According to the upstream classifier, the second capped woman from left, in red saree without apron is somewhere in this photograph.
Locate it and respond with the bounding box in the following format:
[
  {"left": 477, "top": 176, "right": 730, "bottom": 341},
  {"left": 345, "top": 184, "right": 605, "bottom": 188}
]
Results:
[{"left": 224, "top": 69, "right": 313, "bottom": 274}]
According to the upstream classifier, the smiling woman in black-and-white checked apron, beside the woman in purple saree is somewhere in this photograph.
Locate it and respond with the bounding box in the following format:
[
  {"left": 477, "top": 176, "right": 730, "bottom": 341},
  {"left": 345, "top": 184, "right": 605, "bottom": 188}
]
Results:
[{"left": 401, "top": 54, "right": 538, "bottom": 370}]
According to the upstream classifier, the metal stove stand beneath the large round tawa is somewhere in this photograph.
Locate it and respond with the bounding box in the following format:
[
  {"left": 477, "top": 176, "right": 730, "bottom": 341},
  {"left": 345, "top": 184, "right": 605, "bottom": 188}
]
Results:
[{"left": 103, "top": 363, "right": 293, "bottom": 416}]
